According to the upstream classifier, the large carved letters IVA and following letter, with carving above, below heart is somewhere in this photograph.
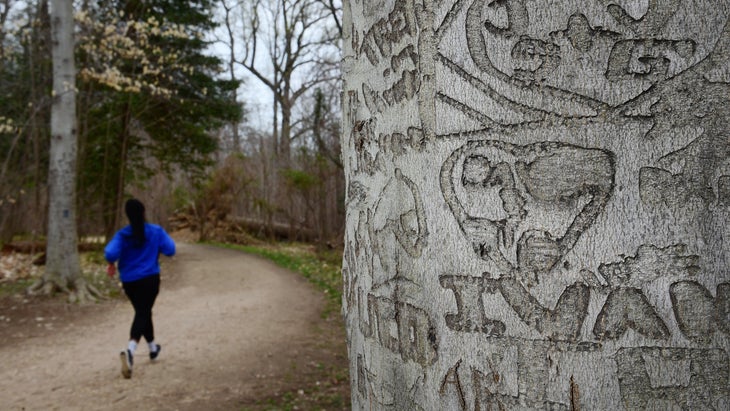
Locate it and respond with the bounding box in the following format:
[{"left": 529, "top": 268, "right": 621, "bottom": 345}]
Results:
[{"left": 439, "top": 245, "right": 730, "bottom": 342}]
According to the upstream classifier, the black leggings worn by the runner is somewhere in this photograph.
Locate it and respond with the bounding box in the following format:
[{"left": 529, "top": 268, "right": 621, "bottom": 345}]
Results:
[{"left": 122, "top": 274, "right": 160, "bottom": 342}]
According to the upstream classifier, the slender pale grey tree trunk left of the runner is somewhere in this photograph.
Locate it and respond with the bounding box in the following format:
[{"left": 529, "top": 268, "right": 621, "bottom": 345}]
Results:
[{"left": 46, "top": 0, "right": 81, "bottom": 288}]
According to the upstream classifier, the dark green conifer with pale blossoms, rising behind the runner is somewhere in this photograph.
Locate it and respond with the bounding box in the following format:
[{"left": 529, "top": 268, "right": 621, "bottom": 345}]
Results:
[{"left": 77, "top": 0, "right": 242, "bottom": 236}]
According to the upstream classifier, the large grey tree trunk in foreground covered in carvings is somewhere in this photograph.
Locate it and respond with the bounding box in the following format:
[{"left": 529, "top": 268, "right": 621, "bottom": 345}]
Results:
[{"left": 343, "top": 0, "right": 730, "bottom": 410}]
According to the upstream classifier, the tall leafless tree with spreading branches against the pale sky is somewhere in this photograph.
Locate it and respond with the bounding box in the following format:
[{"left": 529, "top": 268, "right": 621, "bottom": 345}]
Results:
[{"left": 208, "top": 0, "right": 339, "bottom": 238}]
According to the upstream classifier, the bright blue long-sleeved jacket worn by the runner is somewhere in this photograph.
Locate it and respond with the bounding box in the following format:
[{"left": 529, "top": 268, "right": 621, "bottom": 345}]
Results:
[{"left": 104, "top": 223, "right": 175, "bottom": 283}]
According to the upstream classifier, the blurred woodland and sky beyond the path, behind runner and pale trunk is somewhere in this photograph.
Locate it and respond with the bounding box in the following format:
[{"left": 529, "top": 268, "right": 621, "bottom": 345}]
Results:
[{"left": 0, "top": 0, "right": 344, "bottom": 247}]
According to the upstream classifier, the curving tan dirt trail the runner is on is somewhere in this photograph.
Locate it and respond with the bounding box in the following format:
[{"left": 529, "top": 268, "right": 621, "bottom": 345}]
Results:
[{"left": 0, "top": 244, "right": 324, "bottom": 410}]
